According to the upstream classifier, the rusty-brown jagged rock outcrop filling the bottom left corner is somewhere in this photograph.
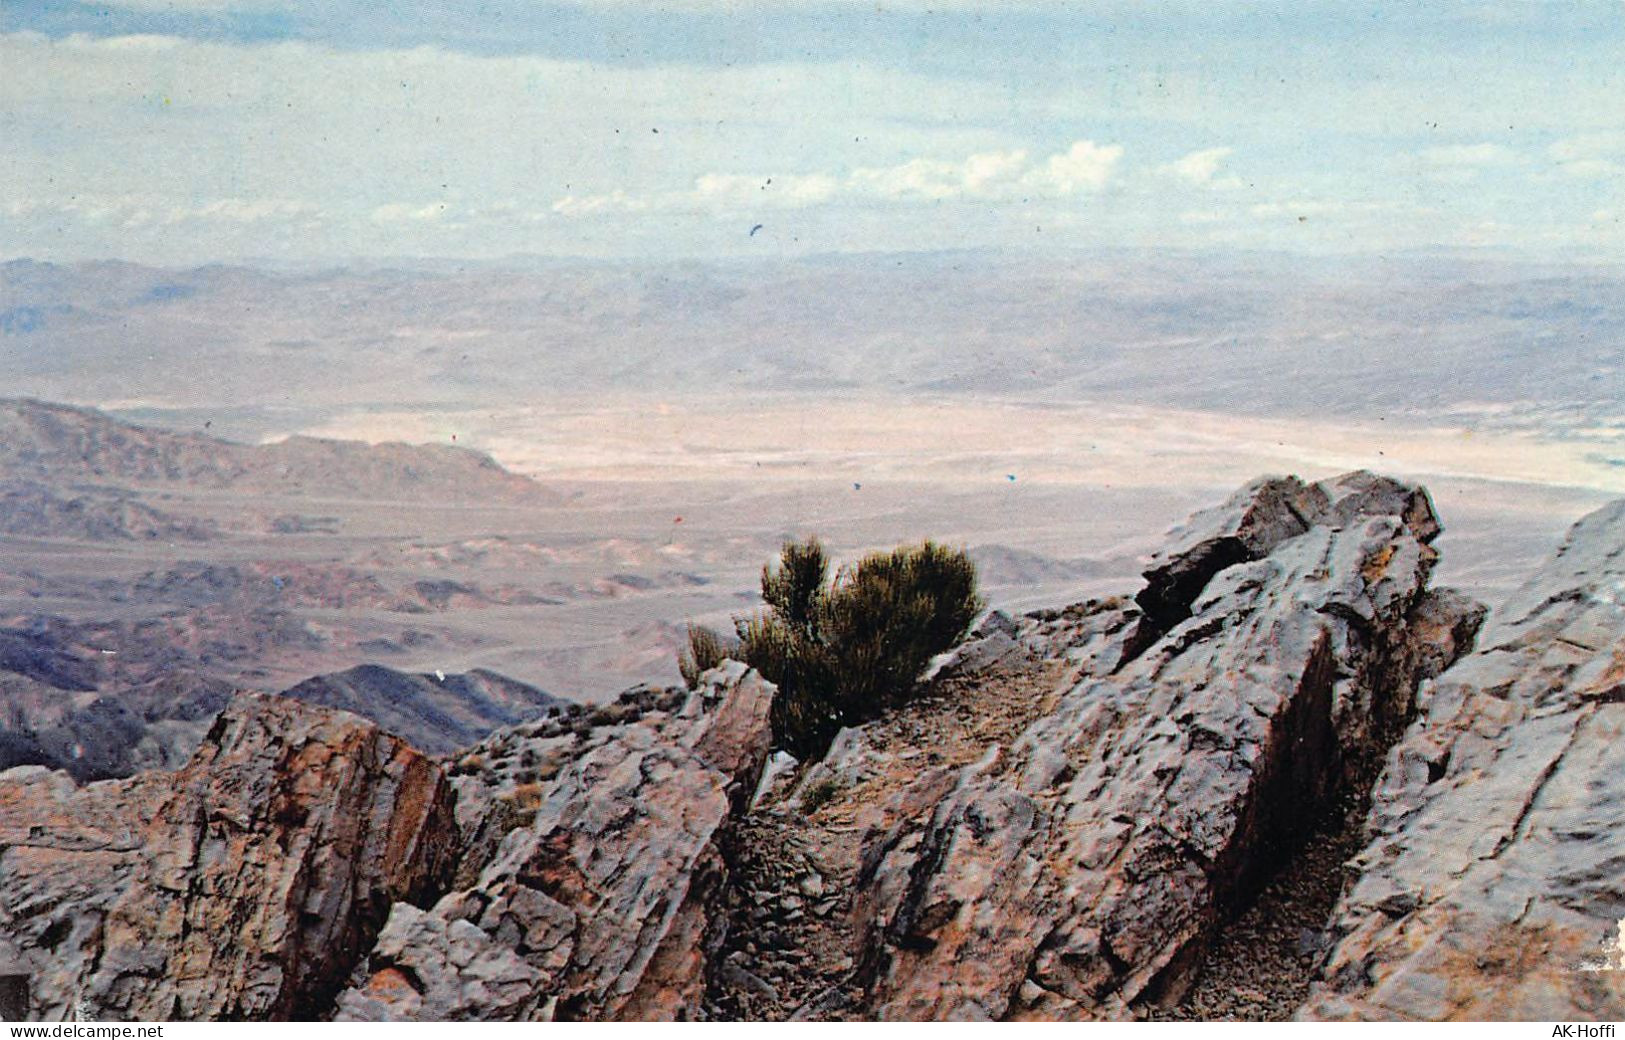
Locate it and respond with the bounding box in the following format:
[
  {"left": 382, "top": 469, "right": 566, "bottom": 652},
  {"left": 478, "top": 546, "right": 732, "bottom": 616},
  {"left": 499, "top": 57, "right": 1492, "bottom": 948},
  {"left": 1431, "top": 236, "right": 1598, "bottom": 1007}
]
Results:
[{"left": 0, "top": 694, "right": 457, "bottom": 1021}]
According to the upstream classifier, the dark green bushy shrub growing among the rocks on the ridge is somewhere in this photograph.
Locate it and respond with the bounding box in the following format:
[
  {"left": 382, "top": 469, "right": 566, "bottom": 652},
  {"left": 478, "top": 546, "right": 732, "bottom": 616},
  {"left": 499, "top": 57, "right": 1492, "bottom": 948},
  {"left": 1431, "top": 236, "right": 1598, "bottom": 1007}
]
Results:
[{"left": 702, "top": 538, "right": 982, "bottom": 759}]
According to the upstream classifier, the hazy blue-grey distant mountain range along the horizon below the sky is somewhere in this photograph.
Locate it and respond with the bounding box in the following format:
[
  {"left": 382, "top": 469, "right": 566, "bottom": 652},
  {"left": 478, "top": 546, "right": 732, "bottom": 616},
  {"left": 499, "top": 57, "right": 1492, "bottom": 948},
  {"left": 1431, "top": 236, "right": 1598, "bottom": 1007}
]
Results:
[{"left": 0, "top": 252, "right": 1625, "bottom": 437}]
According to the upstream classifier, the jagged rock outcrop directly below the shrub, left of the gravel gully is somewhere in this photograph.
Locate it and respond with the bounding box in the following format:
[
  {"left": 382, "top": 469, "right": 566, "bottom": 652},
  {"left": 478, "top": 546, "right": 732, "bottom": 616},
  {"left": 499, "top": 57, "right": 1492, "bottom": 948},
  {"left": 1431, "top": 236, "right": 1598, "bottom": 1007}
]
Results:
[{"left": 338, "top": 661, "right": 774, "bottom": 1021}]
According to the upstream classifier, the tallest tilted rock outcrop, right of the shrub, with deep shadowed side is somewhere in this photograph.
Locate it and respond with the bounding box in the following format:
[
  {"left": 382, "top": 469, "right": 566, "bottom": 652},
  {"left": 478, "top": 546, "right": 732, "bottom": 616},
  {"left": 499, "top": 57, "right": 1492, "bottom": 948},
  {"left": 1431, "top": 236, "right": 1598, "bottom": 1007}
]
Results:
[{"left": 855, "top": 473, "right": 1477, "bottom": 1019}]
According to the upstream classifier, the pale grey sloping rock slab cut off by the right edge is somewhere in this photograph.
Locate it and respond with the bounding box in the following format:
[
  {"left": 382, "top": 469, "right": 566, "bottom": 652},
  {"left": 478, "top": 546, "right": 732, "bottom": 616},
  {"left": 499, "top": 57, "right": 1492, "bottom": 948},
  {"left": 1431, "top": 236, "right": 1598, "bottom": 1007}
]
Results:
[{"left": 1300, "top": 502, "right": 1625, "bottom": 1021}]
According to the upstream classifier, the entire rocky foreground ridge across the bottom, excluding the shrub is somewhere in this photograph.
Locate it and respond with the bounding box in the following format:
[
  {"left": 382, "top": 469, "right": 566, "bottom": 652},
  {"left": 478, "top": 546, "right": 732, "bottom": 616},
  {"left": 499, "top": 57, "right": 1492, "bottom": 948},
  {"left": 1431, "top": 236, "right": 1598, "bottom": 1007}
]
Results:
[{"left": 0, "top": 473, "right": 1625, "bottom": 1021}]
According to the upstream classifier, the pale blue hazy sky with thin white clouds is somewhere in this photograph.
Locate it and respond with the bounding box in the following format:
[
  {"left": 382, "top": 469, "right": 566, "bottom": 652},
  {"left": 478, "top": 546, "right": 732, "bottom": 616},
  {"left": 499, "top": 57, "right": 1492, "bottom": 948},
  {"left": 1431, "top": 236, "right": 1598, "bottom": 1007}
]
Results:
[{"left": 0, "top": 0, "right": 1625, "bottom": 263}]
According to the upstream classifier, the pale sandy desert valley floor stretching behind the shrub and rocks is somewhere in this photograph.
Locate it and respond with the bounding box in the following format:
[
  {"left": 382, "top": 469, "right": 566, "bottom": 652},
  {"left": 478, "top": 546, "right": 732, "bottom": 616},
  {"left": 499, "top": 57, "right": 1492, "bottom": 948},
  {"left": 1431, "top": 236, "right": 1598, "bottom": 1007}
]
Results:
[{"left": 0, "top": 397, "right": 1625, "bottom": 711}]
